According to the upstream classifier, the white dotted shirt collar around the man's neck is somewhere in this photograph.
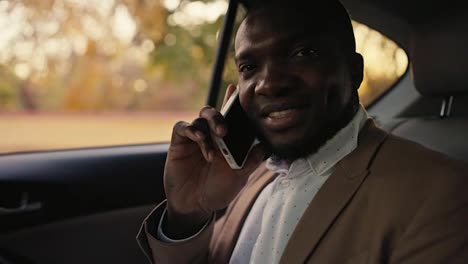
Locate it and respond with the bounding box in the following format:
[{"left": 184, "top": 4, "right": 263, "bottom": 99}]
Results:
[{"left": 266, "top": 106, "right": 369, "bottom": 177}]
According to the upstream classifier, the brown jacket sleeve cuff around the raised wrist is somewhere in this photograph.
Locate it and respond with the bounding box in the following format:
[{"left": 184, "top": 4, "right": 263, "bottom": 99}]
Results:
[{"left": 137, "top": 201, "right": 215, "bottom": 264}]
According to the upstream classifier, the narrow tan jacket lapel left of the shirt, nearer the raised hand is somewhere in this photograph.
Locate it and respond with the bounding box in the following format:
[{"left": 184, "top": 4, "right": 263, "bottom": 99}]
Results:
[{"left": 210, "top": 163, "right": 276, "bottom": 263}]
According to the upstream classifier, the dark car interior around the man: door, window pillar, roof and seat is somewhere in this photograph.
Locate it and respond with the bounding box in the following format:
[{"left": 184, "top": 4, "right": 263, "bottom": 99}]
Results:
[{"left": 0, "top": 0, "right": 468, "bottom": 264}]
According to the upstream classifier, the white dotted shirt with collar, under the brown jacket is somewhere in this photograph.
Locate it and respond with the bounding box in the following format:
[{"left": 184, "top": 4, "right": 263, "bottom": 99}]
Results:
[{"left": 230, "top": 107, "right": 368, "bottom": 264}]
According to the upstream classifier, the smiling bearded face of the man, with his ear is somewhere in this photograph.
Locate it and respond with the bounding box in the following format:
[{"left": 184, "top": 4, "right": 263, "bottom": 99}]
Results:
[{"left": 235, "top": 7, "right": 362, "bottom": 160}]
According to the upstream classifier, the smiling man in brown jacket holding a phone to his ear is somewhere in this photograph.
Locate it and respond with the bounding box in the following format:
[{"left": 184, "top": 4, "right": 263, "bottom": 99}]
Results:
[{"left": 138, "top": 0, "right": 468, "bottom": 263}]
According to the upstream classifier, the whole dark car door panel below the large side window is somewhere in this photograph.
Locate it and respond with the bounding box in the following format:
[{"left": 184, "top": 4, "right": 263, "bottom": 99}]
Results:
[{"left": 0, "top": 144, "right": 168, "bottom": 263}]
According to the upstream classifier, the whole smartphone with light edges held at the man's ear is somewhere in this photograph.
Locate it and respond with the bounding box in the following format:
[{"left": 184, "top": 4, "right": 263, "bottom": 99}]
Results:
[{"left": 214, "top": 89, "right": 258, "bottom": 169}]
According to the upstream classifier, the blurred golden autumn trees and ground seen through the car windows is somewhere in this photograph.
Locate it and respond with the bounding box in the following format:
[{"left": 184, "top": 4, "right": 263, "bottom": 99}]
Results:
[{"left": 0, "top": 0, "right": 408, "bottom": 153}]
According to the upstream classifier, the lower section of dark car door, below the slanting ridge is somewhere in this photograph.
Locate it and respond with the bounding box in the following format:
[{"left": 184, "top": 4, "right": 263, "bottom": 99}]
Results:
[{"left": 0, "top": 205, "right": 153, "bottom": 264}]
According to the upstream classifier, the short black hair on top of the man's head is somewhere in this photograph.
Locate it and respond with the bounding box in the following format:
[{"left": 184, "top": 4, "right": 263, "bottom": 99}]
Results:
[{"left": 245, "top": 0, "right": 356, "bottom": 55}]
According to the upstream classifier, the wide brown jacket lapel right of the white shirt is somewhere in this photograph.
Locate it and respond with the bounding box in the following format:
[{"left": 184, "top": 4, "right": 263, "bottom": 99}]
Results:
[{"left": 280, "top": 120, "right": 387, "bottom": 263}]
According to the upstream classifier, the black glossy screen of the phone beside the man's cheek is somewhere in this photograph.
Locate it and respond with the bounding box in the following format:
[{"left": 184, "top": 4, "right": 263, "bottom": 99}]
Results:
[{"left": 223, "top": 96, "right": 256, "bottom": 166}]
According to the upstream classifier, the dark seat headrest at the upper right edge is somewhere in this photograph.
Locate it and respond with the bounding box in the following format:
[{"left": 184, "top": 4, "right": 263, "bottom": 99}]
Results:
[{"left": 411, "top": 16, "right": 468, "bottom": 97}]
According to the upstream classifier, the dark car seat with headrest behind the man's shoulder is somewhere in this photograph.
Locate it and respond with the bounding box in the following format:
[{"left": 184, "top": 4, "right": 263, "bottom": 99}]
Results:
[{"left": 384, "top": 14, "right": 468, "bottom": 160}]
